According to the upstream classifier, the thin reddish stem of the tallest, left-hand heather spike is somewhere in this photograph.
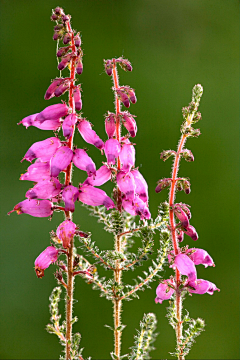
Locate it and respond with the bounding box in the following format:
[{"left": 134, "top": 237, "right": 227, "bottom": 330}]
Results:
[{"left": 65, "top": 21, "right": 76, "bottom": 360}]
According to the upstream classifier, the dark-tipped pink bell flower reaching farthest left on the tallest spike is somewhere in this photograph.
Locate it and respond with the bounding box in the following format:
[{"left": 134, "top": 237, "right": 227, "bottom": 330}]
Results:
[{"left": 8, "top": 199, "right": 53, "bottom": 217}]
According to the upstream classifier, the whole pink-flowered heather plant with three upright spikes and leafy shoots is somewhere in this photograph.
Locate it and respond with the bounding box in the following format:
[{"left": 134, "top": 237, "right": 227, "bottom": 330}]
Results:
[{"left": 10, "top": 7, "right": 218, "bottom": 360}]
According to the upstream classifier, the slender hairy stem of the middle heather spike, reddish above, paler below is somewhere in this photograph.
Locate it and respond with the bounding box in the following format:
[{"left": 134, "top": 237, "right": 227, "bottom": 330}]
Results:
[{"left": 112, "top": 60, "right": 122, "bottom": 359}]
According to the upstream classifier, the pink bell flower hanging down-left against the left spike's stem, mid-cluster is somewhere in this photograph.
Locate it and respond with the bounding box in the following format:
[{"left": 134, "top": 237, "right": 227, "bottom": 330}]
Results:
[{"left": 50, "top": 146, "right": 73, "bottom": 177}]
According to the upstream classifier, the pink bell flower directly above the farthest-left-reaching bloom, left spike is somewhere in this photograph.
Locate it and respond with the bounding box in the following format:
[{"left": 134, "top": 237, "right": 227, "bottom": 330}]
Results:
[{"left": 26, "top": 178, "right": 62, "bottom": 199}]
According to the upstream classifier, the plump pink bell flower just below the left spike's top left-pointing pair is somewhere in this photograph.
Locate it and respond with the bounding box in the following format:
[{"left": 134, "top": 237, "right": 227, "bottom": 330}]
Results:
[{"left": 22, "top": 137, "right": 61, "bottom": 162}]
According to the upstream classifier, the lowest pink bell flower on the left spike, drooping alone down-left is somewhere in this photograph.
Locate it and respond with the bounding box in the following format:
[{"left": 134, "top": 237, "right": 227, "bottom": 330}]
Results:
[{"left": 35, "top": 246, "right": 59, "bottom": 278}]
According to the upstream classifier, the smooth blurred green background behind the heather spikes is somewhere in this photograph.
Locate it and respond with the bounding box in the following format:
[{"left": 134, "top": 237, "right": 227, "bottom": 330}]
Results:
[{"left": 0, "top": 0, "right": 239, "bottom": 359}]
